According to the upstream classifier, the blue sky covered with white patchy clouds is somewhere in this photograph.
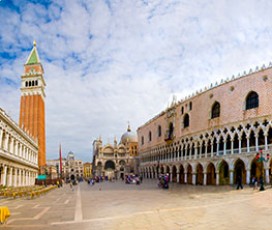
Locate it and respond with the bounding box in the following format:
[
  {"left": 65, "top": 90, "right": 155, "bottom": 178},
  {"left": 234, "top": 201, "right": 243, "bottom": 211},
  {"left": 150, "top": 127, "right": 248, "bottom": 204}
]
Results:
[{"left": 0, "top": 0, "right": 272, "bottom": 162}]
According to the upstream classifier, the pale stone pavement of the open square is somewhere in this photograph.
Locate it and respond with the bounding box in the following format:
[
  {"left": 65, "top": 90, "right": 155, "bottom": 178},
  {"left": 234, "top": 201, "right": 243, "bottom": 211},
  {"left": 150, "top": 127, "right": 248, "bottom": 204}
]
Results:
[{"left": 0, "top": 180, "right": 272, "bottom": 230}]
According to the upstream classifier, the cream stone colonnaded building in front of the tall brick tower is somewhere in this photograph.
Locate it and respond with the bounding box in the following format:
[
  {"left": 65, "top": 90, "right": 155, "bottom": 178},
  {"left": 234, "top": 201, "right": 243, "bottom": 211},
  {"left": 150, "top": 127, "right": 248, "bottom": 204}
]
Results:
[{"left": 0, "top": 108, "right": 38, "bottom": 187}]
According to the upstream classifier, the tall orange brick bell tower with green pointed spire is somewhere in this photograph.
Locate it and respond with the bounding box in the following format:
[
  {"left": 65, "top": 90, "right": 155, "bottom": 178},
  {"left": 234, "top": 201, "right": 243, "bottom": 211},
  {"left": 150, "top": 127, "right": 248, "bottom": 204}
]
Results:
[{"left": 19, "top": 41, "right": 46, "bottom": 173}]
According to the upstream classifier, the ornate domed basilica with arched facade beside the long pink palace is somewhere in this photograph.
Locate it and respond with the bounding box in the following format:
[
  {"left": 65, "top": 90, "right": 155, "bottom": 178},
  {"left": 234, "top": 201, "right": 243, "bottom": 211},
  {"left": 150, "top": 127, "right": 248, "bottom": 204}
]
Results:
[{"left": 93, "top": 125, "right": 138, "bottom": 179}]
